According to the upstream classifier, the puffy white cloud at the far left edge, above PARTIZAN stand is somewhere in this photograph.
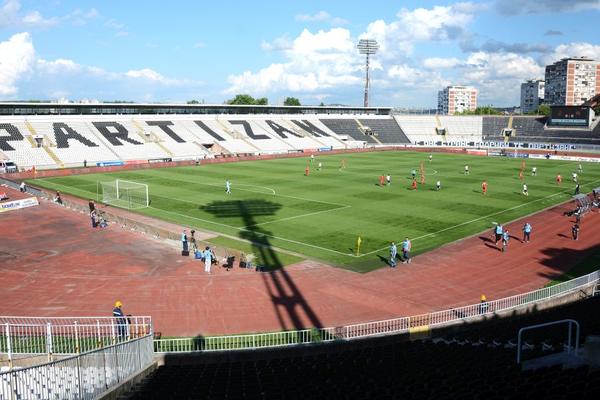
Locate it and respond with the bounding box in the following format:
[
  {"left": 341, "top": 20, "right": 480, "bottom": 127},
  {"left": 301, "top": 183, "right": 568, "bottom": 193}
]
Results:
[{"left": 0, "top": 32, "right": 35, "bottom": 96}]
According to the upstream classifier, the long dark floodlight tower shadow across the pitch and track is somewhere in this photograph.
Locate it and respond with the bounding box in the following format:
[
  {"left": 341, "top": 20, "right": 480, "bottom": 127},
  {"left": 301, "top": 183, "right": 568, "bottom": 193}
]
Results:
[{"left": 200, "top": 199, "right": 322, "bottom": 330}]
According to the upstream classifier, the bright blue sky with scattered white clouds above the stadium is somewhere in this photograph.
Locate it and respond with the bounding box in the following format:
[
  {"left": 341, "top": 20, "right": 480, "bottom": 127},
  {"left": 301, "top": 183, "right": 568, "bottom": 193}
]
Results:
[{"left": 0, "top": 0, "right": 600, "bottom": 108}]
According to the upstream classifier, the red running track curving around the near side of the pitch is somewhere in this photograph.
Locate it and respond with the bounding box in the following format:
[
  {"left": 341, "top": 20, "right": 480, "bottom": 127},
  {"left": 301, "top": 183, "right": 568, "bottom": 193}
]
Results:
[{"left": 0, "top": 186, "right": 600, "bottom": 336}]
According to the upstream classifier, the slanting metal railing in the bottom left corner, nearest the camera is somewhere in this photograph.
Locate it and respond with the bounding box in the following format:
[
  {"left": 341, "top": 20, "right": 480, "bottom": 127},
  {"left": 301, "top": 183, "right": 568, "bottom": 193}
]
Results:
[{"left": 0, "top": 335, "right": 154, "bottom": 400}]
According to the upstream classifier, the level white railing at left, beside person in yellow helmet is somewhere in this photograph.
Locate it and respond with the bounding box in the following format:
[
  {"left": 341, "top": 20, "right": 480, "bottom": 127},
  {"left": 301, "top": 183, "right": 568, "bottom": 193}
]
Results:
[{"left": 0, "top": 316, "right": 153, "bottom": 366}]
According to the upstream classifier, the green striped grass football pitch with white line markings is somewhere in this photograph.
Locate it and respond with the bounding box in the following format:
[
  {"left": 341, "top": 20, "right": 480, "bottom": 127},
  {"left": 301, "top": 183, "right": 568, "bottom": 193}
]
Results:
[{"left": 30, "top": 151, "right": 600, "bottom": 272}]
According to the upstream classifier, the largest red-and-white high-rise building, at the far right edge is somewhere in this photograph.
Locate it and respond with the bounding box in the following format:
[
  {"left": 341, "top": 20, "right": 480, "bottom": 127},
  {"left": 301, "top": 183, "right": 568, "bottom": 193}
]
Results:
[{"left": 544, "top": 57, "right": 600, "bottom": 106}]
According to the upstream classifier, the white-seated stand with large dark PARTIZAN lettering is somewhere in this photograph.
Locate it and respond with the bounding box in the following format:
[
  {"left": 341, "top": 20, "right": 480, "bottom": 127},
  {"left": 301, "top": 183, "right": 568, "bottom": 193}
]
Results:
[{"left": 0, "top": 114, "right": 372, "bottom": 168}]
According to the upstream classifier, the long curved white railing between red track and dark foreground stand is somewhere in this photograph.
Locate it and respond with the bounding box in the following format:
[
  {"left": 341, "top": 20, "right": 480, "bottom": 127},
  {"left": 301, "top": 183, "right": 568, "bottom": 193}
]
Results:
[{"left": 154, "top": 270, "right": 600, "bottom": 353}]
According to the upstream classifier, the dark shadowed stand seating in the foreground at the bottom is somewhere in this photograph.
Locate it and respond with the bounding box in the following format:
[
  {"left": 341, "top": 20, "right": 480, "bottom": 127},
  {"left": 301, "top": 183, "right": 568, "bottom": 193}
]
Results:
[{"left": 128, "top": 297, "right": 600, "bottom": 400}]
